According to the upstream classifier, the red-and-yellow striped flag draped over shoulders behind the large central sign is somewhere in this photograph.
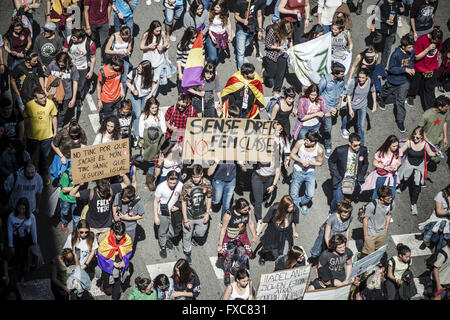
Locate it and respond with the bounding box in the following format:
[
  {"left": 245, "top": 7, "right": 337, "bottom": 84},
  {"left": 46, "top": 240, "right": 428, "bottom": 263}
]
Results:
[{"left": 221, "top": 71, "right": 264, "bottom": 119}]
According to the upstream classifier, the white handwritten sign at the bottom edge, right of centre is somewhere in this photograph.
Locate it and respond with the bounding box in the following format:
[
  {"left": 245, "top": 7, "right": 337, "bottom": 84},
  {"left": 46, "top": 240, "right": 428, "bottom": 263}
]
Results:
[{"left": 256, "top": 265, "right": 311, "bottom": 300}]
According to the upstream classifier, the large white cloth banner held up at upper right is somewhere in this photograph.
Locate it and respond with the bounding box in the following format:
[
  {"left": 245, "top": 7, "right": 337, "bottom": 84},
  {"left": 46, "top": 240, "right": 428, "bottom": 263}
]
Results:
[{"left": 287, "top": 32, "right": 352, "bottom": 87}]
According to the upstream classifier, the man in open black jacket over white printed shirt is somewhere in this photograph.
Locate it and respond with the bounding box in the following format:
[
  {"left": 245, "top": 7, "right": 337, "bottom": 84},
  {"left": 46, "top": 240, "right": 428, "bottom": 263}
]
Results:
[{"left": 328, "top": 133, "right": 369, "bottom": 213}]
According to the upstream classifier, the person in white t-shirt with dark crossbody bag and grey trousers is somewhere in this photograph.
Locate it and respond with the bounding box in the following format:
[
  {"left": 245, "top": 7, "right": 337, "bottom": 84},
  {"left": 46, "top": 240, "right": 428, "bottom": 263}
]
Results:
[{"left": 153, "top": 170, "right": 183, "bottom": 259}]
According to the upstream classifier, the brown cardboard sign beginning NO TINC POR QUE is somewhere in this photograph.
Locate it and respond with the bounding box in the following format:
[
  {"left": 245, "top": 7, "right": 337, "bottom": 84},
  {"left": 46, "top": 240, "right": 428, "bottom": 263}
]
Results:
[{"left": 71, "top": 139, "right": 130, "bottom": 184}]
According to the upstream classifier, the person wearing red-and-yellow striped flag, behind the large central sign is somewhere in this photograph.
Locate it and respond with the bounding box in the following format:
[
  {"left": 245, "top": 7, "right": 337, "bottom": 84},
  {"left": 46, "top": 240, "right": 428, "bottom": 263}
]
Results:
[{"left": 221, "top": 63, "right": 264, "bottom": 119}]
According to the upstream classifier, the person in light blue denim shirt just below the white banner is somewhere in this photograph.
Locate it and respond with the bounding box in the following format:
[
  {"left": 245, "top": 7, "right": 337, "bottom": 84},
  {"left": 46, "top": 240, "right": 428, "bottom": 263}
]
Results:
[{"left": 319, "top": 62, "right": 345, "bottom": 159}]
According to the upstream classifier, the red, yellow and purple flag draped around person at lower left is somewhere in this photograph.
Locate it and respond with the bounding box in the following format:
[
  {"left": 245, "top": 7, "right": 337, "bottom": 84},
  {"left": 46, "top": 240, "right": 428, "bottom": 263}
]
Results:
[{"left": 97, "top": 230, "right": 133, "bottom": 274}]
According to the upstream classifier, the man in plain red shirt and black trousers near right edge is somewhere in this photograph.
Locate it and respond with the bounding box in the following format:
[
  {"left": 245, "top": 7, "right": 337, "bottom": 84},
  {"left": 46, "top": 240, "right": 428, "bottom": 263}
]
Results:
[{"left": 407, "top": 27, "right": 443, "bottom": 111}]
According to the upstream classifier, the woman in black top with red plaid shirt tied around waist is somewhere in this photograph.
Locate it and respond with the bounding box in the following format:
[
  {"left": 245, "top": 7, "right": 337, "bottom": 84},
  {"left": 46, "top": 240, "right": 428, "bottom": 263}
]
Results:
[{"left": 217, "top": 198, "right": 259, "bottom": 286}]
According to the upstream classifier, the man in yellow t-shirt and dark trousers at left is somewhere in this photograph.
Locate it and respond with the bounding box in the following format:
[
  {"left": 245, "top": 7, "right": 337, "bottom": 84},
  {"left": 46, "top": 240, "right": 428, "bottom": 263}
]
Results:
[{"left": 23, "top": 88, "right": 58, "bottom": 184}]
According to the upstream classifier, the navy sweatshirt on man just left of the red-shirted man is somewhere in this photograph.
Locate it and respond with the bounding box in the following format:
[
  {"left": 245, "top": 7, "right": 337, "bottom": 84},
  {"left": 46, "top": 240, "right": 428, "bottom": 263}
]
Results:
[{"left": 387, "top": 47, "right": 415, "bottom": 85}]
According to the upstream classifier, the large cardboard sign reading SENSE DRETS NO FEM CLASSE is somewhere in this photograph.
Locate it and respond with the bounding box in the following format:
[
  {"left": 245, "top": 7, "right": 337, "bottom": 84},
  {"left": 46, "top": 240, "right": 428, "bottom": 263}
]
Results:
[{"left": 183, "top": 118, "right": 275, "bottom": 162}]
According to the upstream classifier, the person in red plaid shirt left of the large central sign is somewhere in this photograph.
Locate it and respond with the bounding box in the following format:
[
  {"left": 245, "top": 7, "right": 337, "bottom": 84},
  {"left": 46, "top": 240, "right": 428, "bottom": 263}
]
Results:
[{"left": 164, "top": 93, "right": 198, "bottom": 142}]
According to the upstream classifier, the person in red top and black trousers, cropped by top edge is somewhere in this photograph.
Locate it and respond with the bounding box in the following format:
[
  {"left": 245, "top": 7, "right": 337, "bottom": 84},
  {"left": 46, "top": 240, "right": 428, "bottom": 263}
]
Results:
[{"left": 278, "top": 0, "right": 311, "bottom": 45}]
